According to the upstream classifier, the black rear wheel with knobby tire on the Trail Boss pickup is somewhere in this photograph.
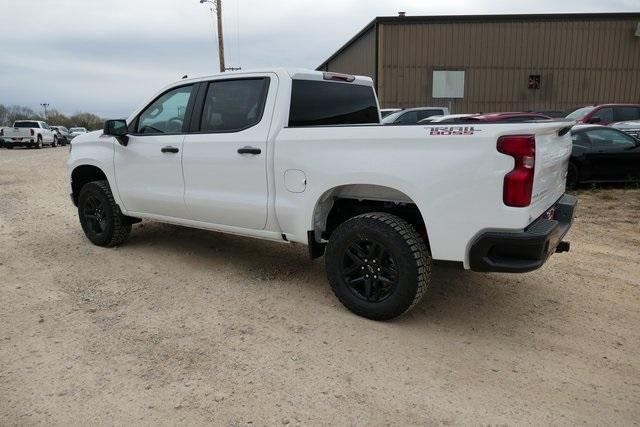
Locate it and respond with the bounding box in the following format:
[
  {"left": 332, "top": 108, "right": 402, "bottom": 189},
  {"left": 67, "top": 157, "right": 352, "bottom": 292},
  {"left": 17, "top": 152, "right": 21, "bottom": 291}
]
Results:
[{"left": 325, "top": 212, "right": 432, "bottom": 320}]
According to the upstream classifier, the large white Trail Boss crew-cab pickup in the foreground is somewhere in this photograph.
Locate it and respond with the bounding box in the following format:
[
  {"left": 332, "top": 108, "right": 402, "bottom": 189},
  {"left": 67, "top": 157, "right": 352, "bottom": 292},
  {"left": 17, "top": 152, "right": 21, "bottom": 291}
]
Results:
[{"left": 67, "top": 69, "right": 576, "bottom": 320}]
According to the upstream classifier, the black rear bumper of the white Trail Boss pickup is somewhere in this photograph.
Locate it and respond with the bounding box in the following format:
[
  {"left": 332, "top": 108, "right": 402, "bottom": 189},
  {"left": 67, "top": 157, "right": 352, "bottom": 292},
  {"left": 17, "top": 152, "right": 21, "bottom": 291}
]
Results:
[{"left": 469, "top": 194, "right": 578, "bottom": 273}]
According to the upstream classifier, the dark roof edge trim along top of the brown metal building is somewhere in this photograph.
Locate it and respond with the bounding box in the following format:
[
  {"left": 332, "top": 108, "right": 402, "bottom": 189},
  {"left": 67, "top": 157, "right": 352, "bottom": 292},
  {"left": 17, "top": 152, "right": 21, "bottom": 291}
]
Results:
[{"left": 316, "top": 11, "right": 640, "bottom": 70}]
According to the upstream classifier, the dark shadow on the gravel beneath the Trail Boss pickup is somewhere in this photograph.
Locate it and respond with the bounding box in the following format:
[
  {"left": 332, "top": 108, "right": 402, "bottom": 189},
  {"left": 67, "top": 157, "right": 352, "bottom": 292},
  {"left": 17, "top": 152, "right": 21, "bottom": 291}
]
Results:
[{"left": 123, "top": 222, "right": 562, "bottom": 335}]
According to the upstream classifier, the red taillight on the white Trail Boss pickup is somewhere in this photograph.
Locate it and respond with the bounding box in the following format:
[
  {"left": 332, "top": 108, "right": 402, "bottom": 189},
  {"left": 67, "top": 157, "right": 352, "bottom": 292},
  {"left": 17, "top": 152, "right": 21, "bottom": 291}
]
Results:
[{"left": 497, "top": 135, "right": 536, "bottom": 208}]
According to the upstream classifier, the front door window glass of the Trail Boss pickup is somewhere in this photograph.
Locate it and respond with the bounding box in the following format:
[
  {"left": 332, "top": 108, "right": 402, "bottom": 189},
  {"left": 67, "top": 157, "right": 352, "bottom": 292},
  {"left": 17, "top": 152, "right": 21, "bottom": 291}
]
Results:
[{"left": 136, "top": 85, "right": 193, "bottom": 135}]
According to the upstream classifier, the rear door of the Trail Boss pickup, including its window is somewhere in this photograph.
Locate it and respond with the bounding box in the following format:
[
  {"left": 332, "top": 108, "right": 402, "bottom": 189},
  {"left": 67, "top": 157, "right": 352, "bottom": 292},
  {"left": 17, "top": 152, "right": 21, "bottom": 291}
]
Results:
[{"left": 182, "top": 74, "right": 278, "bottom": 230}]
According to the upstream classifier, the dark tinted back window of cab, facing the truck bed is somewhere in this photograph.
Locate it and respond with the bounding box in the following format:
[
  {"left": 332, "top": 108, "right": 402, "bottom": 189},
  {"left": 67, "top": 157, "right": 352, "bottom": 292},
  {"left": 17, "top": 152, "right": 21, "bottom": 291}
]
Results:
[{"left": 289, "top": 80, "right": 380, "bottom": 127}]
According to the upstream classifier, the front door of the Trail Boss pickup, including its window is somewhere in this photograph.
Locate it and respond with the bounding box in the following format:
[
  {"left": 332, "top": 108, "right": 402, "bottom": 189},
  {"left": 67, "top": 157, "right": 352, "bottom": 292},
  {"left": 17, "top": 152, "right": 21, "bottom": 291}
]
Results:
[{"left": 114, "top": 85, "right": 194, "bottom": 218}]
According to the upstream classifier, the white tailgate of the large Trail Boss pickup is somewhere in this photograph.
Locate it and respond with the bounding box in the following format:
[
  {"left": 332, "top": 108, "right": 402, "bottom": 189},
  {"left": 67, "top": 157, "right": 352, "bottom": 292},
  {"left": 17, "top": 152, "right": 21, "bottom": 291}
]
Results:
[{"left": 530, "top": 122, "right": 572, "bottom": 218}]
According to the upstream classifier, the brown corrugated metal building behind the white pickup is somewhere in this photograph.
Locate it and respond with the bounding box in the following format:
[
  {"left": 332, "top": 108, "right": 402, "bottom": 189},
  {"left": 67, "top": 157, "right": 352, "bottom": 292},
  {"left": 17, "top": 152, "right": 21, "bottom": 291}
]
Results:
[{"left": 318, "top": 12, "right": 640, "bottom": 113}]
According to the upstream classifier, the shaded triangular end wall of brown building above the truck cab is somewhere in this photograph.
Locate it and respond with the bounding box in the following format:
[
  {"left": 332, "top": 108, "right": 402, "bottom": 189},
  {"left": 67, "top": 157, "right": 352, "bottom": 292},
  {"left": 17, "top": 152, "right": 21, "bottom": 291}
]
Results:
[{"left": 326, "top": 26, "right": 376, "bottom": 78}]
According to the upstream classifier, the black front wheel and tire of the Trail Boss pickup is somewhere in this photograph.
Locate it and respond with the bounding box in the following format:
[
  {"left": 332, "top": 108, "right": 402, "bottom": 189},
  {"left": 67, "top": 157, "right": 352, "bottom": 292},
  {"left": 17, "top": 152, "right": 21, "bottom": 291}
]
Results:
[{"left": 78, "top": 180, "right": 131, "bottom": 247}]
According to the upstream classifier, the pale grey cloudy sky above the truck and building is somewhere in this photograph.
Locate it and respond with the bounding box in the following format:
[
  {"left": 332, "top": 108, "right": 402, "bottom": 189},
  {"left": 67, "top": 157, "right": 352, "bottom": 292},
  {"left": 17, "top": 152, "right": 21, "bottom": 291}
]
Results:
[{"left": 0, "top": 0, "right": 640, "bottom": 117}]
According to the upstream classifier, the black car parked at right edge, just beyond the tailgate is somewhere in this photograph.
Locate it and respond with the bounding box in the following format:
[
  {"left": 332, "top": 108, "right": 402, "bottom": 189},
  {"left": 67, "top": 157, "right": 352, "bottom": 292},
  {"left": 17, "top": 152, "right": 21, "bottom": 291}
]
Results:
[{"left": 567, "top": 125, "right": 640, "bottom": 187}]
